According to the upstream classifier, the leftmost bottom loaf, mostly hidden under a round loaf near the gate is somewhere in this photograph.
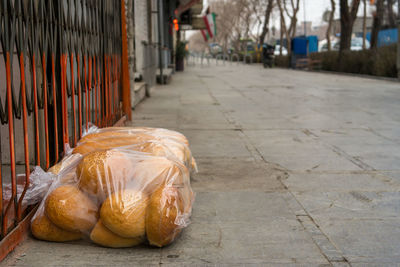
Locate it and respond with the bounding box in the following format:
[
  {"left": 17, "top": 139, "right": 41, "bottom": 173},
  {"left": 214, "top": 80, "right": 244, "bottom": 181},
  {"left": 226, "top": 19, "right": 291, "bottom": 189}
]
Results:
[{"left": 31, "top": 212, "right": 82, "bottom": 242}]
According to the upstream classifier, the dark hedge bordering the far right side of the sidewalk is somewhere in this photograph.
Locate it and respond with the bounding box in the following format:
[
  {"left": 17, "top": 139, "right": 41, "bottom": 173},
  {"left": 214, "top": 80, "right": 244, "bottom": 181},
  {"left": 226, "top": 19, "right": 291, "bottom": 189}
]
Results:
[{"left": 275, "top": 45, "right": 397, "bottom": 78}]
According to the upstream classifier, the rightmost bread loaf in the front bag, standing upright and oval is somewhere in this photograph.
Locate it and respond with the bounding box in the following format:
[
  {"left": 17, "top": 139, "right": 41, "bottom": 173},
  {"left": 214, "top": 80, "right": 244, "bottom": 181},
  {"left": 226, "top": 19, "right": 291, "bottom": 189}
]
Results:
[{"left": 146, "top": 186, "right": 184, "bottom": 247}]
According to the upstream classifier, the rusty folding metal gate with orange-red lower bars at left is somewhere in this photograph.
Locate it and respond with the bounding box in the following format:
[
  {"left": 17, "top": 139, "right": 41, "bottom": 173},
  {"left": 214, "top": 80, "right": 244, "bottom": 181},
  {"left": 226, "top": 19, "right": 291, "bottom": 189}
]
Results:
[{"left": 0, "top": 0, "right": 129, "bottom": 259}]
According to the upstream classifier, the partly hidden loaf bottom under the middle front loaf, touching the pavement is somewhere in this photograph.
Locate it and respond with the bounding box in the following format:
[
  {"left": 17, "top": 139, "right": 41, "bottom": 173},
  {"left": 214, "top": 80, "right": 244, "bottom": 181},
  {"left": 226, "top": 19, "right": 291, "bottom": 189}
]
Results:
[{"left": 90, "top": 220, "right": 143, "bottom": 248}]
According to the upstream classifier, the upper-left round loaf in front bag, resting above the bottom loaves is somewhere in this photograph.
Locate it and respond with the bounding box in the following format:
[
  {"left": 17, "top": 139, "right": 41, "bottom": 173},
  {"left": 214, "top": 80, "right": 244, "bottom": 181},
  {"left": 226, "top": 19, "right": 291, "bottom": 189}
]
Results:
[{"left": 77, "top": 150, "right": 132, "bottom": 200}]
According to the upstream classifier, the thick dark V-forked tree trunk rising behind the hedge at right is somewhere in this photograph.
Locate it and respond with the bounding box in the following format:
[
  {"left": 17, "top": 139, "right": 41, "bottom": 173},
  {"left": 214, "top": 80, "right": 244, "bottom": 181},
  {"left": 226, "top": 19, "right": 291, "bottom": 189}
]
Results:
[{"left": 339, "top": 0, "right": 361, "bottom": 54}]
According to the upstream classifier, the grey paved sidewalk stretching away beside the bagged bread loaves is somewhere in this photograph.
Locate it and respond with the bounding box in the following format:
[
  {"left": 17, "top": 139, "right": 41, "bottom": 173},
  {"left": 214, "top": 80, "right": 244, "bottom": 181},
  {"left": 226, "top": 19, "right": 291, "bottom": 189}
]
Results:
[{"left": 3, "top": 65, "right": 400, "bottom": 266}]
